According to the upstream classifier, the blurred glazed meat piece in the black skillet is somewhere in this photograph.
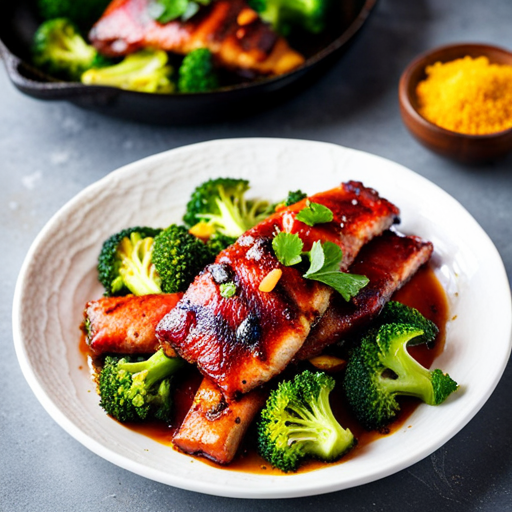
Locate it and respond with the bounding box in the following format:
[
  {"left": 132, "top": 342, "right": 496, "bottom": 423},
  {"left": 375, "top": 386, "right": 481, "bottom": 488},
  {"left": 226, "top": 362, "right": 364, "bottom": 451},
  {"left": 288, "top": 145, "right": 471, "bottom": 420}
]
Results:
[{"left": 89, "top": 0, "right": 304, "bottom": 75}]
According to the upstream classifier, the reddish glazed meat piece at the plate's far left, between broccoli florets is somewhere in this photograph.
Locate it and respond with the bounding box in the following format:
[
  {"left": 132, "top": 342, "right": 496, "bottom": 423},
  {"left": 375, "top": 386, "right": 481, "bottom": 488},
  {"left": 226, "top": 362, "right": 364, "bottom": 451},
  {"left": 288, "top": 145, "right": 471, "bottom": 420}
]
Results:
[{"left": 82, "top": 293, "right": 183, "bottom": 356}]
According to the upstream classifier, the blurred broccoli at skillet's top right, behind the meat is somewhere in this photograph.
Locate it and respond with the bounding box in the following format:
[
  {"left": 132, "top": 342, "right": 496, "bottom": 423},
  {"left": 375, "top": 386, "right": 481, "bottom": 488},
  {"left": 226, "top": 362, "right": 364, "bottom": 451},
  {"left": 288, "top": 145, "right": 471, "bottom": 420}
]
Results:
[{"left": 257, "top": 0, "right": 330, "bottom": 35}]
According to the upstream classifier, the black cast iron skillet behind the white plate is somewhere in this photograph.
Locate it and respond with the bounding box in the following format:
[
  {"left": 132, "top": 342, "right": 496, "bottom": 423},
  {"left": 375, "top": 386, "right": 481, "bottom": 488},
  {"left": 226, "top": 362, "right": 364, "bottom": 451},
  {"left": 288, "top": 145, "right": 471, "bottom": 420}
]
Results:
[{"left": 0, "top": 0, "right": 377, "bottom": 125}]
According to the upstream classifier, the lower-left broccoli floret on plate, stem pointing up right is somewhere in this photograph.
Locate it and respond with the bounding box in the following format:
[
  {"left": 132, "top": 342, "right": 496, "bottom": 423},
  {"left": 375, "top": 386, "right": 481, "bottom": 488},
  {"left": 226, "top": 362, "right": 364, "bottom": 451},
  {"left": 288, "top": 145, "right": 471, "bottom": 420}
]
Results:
[{"left": 98, "top": 349, "right": 185, "bottom": 423}]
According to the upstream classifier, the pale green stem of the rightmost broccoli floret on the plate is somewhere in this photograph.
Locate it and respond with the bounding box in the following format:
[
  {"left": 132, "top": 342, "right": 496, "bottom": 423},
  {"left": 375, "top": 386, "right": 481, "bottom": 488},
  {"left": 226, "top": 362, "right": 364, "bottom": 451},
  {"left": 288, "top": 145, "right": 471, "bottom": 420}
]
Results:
[{"left": 378, "top": 330, "right": 436, "bottom": 405}]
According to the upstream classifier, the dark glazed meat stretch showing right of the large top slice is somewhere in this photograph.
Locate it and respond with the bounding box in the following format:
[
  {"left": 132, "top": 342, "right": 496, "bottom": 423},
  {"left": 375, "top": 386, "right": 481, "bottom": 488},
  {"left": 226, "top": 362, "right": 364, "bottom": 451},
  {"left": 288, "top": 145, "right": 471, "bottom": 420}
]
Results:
[{"left": 295, "top": 231, "right": 433, "bottom": 361}]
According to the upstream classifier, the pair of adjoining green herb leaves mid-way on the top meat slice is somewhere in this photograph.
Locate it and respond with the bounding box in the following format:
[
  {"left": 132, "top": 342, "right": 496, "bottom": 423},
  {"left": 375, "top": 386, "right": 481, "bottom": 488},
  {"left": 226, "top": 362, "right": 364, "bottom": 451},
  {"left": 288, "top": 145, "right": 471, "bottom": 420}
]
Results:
[{"left": 272, "top": 232, "right": 370, "bottom": 301}]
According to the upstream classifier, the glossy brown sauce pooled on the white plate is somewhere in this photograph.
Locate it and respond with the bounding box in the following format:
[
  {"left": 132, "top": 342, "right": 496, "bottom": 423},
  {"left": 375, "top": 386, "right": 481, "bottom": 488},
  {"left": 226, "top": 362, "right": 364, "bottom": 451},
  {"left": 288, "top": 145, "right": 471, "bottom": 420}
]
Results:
[{"left": 80, "top": 265, "right": 448, "bottom": 475}]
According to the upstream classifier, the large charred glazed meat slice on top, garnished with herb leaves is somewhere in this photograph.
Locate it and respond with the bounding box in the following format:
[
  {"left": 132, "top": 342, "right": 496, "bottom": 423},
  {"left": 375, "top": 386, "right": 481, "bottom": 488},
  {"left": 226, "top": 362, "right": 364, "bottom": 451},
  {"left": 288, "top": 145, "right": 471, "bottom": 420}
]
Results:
[{"left": 157, "top": 182, "right": 398, "bottom": 399}]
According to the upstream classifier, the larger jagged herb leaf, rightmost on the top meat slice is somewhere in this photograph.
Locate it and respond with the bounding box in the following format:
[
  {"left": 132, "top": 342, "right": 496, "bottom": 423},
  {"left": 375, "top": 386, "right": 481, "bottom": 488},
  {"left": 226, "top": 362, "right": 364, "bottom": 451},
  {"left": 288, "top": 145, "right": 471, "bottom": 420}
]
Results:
[{"left": 304, "top": 242, "right": 370, "bottom": 301}]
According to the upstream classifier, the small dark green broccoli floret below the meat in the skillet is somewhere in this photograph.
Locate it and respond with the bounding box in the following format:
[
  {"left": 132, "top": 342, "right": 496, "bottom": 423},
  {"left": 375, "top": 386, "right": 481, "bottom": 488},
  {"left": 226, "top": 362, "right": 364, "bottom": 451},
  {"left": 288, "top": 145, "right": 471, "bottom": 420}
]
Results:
[{"left": 178, "top": 48, "right": 219, "bottom": 92}]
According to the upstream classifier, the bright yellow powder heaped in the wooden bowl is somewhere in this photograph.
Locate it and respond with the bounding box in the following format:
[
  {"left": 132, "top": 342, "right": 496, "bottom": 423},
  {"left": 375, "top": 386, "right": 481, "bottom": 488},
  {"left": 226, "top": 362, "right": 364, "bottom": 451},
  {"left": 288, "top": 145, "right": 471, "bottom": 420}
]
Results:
[{"left": 416, "top": 57, "right": 512, "bottom": 135}]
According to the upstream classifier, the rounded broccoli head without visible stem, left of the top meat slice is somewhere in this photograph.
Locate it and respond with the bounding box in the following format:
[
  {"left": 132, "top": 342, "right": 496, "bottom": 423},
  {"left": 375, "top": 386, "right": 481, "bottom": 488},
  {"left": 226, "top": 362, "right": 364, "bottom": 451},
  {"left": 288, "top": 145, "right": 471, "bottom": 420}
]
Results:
[{"left": 152, "top": 224, "right": 215, "bottom": 293}]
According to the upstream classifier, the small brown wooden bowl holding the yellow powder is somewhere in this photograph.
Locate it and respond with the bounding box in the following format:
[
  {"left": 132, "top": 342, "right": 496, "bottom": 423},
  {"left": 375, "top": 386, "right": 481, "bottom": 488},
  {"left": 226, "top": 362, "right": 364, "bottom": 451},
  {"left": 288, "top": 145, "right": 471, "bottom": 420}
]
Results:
[{"left": 398, "top": 44, "right": 512, "bottom": 163}]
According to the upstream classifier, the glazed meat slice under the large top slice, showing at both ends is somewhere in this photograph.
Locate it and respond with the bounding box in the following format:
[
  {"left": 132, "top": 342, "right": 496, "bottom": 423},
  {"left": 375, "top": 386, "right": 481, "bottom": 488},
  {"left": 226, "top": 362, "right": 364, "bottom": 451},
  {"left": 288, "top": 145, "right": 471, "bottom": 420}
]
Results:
[{"left": 173, "top": 231, "right": 433, "bottom": 464}]
